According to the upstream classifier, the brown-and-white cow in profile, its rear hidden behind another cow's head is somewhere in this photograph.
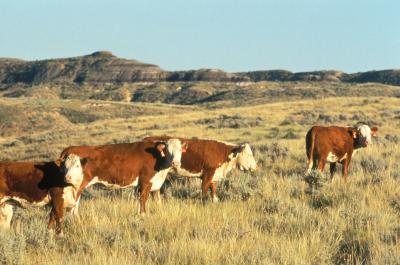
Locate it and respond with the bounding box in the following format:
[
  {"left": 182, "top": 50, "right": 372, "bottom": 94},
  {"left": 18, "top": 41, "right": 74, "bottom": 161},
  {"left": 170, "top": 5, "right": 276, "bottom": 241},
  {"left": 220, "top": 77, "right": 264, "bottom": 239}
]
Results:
[{"left": 144, "top": 136, "right": 257, "bottom": 202}]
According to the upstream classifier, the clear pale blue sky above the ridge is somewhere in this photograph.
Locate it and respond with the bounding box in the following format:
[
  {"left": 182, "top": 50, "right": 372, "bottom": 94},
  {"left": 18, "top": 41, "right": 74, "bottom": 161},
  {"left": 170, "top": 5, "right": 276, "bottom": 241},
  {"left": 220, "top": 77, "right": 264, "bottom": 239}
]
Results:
[{"left": 0, "top": 0, "right": 400, "bottom": 72}]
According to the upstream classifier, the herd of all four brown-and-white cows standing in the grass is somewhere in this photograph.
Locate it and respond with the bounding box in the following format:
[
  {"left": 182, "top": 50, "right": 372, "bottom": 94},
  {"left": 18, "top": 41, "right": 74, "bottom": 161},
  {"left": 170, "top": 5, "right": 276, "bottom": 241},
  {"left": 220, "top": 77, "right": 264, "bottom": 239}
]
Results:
[{"left": 0, "top": 125, "right": 377, "bottom": 235}]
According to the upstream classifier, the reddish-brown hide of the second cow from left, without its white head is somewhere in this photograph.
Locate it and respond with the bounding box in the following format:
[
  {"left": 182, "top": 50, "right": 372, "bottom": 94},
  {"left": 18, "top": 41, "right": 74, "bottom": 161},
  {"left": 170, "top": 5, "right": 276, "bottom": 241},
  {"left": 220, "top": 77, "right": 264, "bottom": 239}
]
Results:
[{"left": 60, "top": 141, "right": 169, "bottom": 213}]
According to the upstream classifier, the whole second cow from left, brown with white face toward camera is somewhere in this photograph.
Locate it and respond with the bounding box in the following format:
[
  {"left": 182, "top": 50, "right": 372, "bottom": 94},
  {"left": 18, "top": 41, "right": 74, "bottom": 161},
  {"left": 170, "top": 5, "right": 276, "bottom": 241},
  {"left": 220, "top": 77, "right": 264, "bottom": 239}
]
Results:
[{"left": 60, "top": 139, "right": 186, "bottom": 214}]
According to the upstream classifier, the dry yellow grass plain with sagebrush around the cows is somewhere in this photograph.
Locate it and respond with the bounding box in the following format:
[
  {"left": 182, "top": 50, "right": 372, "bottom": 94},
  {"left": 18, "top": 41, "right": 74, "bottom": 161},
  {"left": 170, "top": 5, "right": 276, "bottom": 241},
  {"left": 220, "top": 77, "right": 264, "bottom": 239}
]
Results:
[{"left": 0, "top": 84, "right": 400, "bottom": 265}]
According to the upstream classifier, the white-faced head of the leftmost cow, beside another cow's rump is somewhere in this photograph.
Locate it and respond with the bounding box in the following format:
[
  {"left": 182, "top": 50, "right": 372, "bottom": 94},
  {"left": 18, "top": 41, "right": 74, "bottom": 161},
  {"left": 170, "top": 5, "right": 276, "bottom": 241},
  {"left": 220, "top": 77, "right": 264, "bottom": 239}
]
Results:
[{"left": 60, "top": 154, "right": 87, "bottom": 188}]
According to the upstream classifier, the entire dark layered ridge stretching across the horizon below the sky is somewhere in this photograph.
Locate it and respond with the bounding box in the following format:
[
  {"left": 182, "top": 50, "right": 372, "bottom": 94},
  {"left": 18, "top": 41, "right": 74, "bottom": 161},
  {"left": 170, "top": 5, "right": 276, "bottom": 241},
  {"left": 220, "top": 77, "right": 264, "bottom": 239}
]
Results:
[{"left": 0, "top": 51, "right": 400, "bottom": 85}]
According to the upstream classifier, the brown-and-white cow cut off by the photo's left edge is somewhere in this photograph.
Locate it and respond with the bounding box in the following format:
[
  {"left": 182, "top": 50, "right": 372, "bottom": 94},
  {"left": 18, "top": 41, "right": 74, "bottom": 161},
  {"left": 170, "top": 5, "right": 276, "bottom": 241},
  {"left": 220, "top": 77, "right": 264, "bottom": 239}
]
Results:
[{"left": 0, "top": 155, "right": 84, "bottom": 235}]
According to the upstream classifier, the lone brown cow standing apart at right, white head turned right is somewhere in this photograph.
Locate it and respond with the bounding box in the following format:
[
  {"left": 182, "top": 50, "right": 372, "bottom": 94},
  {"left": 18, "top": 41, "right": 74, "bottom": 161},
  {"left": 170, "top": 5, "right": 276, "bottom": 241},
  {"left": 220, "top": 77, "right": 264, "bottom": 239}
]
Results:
[{"left": 306, "top": 124, "right": 378, "bottom": 180}]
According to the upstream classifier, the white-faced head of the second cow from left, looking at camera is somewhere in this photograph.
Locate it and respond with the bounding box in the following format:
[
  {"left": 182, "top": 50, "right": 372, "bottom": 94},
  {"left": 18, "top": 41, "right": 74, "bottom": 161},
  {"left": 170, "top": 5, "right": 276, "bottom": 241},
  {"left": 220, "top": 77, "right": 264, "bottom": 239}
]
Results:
[{"left": 156, "top": 138, "right": 188, "bottom": 168}]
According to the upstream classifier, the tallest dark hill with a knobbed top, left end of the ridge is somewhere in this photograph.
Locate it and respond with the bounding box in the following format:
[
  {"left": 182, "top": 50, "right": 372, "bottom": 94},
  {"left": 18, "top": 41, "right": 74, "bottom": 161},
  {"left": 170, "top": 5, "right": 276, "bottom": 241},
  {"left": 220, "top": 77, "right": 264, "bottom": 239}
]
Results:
[{"left": 0, "top": 52, "right": 166, "bottom": 84}]
